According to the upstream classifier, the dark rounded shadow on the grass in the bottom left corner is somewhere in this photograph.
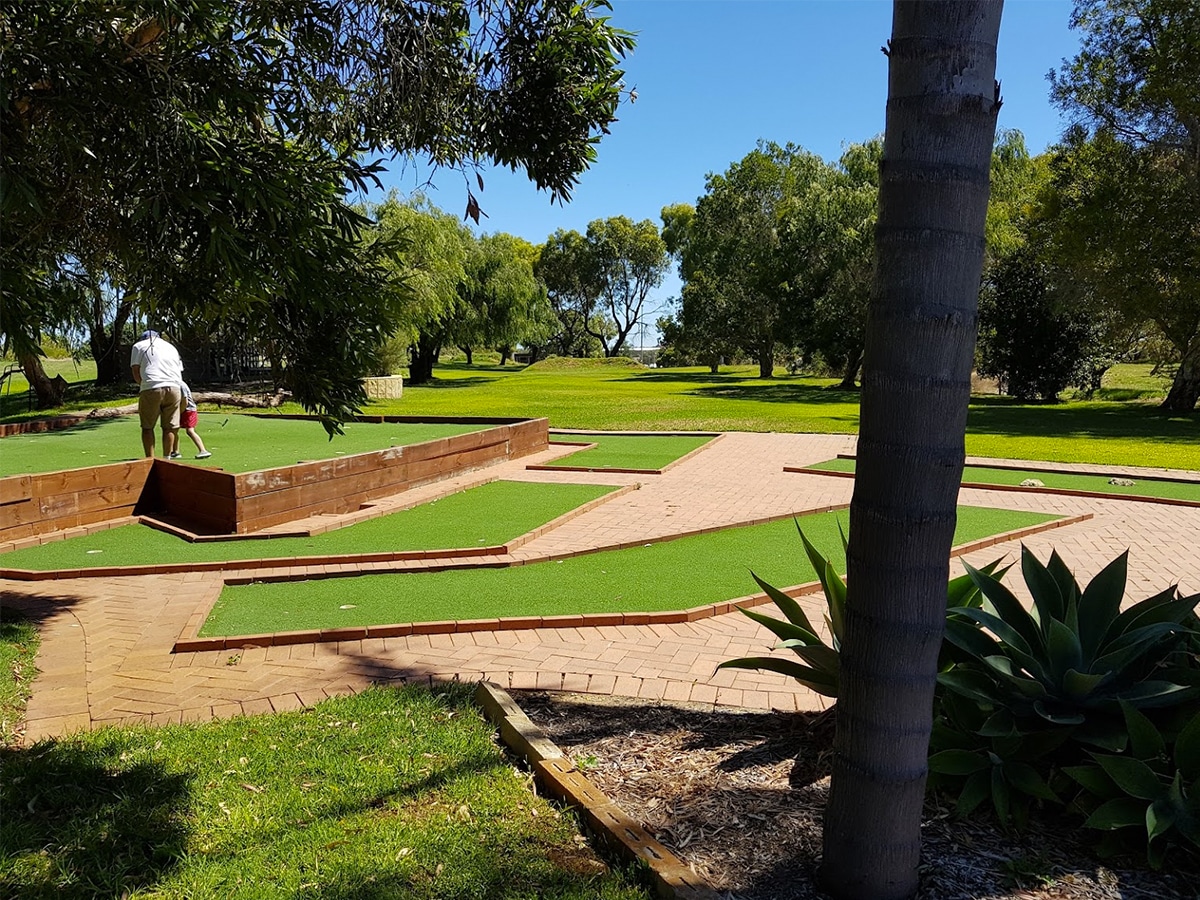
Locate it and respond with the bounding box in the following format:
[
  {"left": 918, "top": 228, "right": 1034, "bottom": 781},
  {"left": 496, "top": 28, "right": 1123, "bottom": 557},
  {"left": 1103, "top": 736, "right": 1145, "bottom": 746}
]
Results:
[{"left": 0, "top": 743, "right": 190, "bottom": 900}]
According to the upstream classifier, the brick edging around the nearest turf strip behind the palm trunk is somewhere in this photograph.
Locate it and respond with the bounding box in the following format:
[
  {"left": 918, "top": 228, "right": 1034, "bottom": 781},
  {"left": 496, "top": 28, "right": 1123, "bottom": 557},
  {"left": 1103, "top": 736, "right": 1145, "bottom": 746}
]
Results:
[{"left": 172, "top": 504, "right": 1092, "bottom": 653}]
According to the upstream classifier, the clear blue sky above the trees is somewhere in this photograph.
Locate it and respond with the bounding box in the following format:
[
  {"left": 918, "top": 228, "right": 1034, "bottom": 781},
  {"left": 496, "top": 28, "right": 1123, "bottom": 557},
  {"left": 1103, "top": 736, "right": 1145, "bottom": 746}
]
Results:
[{"left": 360, "top": 0, "right": 1079, "bottom": 340}]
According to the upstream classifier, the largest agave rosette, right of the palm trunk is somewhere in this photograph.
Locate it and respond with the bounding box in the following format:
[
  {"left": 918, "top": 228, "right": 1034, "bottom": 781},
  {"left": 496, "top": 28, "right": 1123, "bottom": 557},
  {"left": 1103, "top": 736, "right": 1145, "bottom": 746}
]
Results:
[{"left": 938, "top": 547, "right": 1200, "bottom": 750}]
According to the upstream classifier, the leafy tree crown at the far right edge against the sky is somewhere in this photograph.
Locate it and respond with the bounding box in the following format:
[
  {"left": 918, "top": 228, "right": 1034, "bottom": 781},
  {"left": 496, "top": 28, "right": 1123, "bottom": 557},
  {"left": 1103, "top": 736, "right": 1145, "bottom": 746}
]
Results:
[{"left": 1050, "top": 0, "right": 1200, "bottom": 413}]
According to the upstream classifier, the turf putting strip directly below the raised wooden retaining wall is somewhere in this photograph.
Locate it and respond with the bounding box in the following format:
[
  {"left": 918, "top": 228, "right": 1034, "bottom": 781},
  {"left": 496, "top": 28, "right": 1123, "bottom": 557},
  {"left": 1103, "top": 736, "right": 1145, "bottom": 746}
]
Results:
[{"left": 0, "top": 481, "right": 617, "bottom": 571}]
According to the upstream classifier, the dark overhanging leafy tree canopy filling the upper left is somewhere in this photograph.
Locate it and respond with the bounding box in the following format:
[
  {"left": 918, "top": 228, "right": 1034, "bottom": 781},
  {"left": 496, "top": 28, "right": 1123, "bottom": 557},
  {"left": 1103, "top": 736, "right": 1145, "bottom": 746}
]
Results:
[{"left": 0, "top": 0, "right": 632, "bottom": 425}]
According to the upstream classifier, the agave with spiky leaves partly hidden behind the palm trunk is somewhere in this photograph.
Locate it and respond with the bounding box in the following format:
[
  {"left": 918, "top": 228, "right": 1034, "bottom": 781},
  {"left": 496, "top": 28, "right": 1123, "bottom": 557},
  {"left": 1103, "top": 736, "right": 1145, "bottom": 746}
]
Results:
[{"left": 718, "top": 522, "right": 1007, "bottom": 698}]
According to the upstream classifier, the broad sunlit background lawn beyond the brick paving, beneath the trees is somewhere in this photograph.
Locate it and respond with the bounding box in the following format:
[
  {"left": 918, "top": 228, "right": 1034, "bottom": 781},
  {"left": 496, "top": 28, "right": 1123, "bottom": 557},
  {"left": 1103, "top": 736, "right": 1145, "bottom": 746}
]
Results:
[{"left": 357, "top": 360, "right": 1200, "bottom": 470}]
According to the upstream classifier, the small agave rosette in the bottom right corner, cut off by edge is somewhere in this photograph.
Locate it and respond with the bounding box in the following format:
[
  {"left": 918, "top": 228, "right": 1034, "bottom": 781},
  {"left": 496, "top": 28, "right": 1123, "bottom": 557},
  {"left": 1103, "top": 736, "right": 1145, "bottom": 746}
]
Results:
[{"left": 1063, "top": 701, "right": 1200, "bottom": 869}]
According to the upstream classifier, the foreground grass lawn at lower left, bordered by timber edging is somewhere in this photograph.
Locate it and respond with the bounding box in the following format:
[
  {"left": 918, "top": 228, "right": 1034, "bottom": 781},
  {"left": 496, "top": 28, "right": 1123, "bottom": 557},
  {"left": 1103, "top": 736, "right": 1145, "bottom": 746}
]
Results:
[{"left": 0, "top": 685, "right": 650, "bottom": 900}]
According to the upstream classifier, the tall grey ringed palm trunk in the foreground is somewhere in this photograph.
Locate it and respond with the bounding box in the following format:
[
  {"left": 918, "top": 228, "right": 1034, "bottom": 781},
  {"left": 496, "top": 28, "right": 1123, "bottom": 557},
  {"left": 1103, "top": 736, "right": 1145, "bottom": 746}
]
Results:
[{"left": 821, "top": 0, "right": 1002, "bottom": 900}]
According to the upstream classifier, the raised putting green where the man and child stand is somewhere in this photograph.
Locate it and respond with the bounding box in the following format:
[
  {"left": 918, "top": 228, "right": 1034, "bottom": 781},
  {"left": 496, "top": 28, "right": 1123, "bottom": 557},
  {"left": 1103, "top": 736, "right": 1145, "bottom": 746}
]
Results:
[{"left": 0, "top": 412, "right": 488, "bottom": 476}]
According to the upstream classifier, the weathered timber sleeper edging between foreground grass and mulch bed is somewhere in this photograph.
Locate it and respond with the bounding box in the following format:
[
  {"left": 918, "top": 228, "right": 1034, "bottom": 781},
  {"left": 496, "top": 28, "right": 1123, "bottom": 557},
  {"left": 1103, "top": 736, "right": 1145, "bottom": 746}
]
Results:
[{"left": 475, "top": 682, "right": 718, "bottom": 900}]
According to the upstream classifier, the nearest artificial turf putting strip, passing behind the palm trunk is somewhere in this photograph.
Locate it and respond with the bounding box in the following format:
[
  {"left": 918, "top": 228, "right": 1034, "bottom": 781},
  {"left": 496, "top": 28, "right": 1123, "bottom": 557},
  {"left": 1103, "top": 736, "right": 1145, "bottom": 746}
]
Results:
[{"left": 200, "top": 506, "right": 1058, "bottom": 636}]
